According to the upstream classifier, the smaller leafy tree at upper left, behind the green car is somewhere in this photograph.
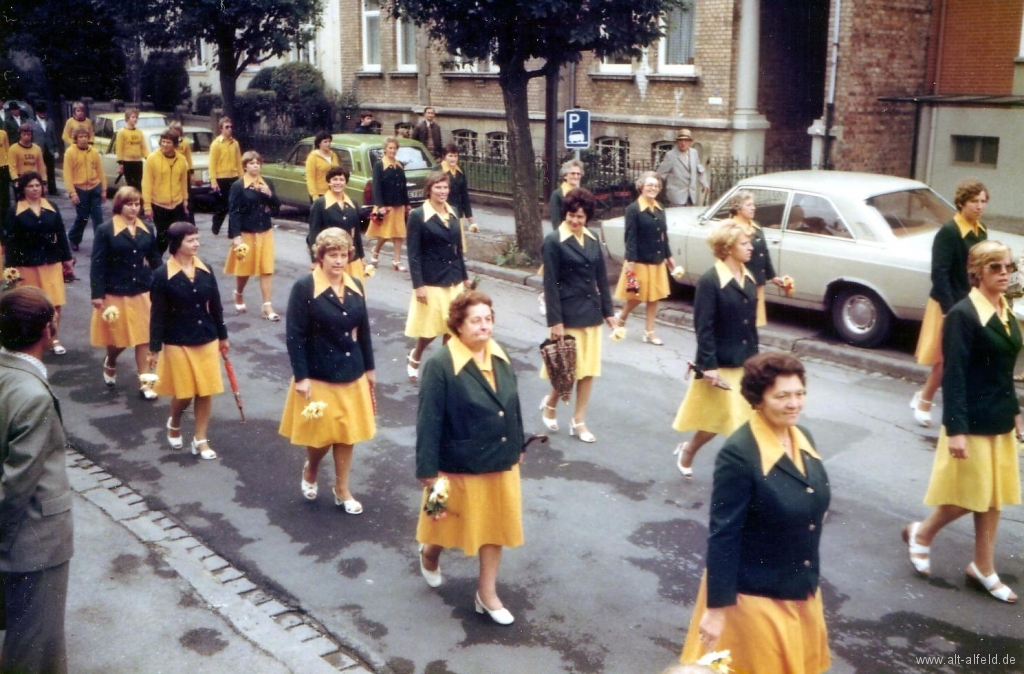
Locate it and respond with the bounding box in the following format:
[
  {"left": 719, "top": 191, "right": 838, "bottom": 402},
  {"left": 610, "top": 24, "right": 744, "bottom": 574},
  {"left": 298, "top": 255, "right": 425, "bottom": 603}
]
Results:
[{"left": 147, "top": 0, "right": 321, "bottom": 116}]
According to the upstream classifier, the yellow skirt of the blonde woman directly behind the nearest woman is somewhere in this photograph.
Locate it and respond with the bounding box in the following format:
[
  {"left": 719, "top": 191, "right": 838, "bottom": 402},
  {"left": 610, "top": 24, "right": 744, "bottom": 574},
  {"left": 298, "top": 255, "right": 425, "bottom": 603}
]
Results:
[{"left": 672, "top": 368, "right": 752, "bottom": 435}]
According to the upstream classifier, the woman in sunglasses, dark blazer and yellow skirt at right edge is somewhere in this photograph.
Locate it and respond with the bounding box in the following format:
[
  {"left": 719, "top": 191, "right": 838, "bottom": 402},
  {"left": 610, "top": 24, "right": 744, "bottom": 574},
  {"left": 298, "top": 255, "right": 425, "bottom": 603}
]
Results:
[{"left": 903, "top": 241, "right": 1024, "bottom": 603}]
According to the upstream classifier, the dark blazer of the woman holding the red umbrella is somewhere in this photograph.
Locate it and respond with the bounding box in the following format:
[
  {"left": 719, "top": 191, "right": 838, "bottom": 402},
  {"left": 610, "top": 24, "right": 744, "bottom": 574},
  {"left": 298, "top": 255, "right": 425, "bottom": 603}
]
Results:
[{"left": 150, "top": 257, "right": 227, "bottom": 353}]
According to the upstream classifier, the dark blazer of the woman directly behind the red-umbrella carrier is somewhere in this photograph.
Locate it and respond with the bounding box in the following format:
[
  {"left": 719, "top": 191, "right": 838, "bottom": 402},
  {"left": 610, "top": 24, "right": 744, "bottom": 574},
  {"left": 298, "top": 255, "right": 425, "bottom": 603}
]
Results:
[{"left": 89, "top": 215, "right": 163, "bottom": 299}]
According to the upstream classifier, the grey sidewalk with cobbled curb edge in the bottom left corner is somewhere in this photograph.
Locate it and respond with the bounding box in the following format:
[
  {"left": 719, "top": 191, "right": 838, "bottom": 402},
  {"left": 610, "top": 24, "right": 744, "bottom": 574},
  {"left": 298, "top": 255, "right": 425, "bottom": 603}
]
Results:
[{"left": 66, "top": 450, "right": 371, "bottom": 674}]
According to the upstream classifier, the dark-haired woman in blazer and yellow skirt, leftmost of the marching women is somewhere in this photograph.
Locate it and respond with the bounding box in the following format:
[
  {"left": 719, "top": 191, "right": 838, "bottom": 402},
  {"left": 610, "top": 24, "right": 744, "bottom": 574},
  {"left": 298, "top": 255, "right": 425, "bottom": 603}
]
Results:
[{"left": 0, "top": 171, "right": 74, "bottom": 355}]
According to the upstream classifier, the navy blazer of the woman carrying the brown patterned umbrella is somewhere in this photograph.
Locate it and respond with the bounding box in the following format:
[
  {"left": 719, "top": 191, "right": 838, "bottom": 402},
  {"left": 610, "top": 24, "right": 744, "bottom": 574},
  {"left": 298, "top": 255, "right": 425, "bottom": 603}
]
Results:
[{"left": 541, "top": 225, "right": 614, "bottom": 328}]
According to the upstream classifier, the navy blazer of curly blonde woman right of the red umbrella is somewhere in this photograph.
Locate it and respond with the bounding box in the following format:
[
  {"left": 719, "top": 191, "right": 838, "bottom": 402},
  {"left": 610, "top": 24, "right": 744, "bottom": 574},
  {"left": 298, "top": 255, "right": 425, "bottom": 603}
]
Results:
[{"left": 285, "top": 267, "right": 374, "bottom": 383}]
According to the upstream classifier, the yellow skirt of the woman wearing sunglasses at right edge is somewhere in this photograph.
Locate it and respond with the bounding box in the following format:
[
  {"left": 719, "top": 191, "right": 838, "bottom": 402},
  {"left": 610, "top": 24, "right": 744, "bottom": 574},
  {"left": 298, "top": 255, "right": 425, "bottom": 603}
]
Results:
[{"left": 925, "top": 426, "right": 1021, "bottom": 512}]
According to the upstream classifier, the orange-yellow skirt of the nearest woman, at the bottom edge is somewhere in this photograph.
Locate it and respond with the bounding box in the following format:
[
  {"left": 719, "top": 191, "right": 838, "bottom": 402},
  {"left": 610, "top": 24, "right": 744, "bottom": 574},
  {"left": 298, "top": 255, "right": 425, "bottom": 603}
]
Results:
[{"left": 679, "top": 572, "right": 831, "bottom": 674}]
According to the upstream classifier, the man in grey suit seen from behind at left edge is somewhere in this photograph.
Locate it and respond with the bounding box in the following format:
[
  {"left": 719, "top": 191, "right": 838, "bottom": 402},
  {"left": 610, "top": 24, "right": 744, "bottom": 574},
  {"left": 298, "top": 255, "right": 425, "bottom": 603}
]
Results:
[{"left": 0, "top": 287, "right": 73, "bottom": 674}]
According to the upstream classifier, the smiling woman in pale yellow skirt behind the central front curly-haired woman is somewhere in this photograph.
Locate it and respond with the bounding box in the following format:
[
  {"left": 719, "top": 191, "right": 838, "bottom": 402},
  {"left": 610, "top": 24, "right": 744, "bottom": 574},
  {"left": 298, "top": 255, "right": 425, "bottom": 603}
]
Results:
[{"left": 406, "top": 171, "right": 469, "bottom": 381}]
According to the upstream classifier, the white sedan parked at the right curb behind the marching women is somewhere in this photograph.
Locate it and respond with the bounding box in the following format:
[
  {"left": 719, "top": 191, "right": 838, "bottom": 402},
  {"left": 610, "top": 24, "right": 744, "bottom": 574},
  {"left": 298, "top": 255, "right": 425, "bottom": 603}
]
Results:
[{"left": 602, "top": 171, "right": 1024, "bottom": 347}]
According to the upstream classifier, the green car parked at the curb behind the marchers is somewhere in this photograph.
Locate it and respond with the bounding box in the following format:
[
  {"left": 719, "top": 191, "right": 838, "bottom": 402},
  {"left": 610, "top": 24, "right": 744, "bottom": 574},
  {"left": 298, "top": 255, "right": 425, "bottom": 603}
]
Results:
[{"left": 261, "top": 133, "right": 438, "bottom": 227}]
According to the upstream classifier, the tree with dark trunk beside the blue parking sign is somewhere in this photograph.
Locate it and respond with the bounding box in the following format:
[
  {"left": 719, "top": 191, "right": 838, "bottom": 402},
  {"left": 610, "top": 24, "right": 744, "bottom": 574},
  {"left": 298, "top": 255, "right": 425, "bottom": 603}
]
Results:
[{"left": 392, "top": 0, "right": 682, "bottom": 253}]
